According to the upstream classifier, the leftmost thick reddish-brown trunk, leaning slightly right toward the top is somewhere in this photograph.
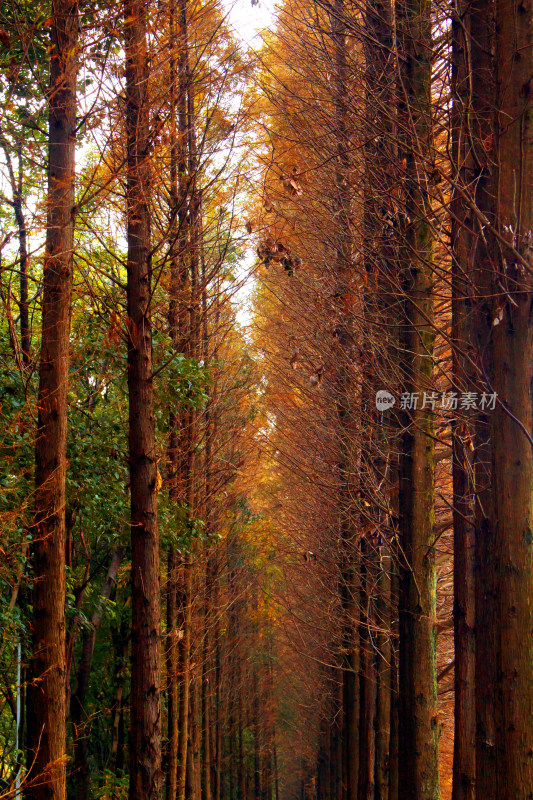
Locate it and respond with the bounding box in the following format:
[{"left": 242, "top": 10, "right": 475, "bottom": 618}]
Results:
[{"left": 26, "top": 0, "right": 79, "bottom": 800}]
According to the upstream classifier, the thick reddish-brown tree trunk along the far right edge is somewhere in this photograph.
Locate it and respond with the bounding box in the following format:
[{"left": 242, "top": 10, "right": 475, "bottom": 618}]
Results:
[{"left": 492, "top": 0, "right": 533, "bottom": 788}]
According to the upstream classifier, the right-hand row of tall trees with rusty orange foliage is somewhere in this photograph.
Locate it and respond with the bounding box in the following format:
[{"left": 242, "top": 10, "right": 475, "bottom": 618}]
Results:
[{"left": 245, "top": 0, "right": 532, "bottom": 800}]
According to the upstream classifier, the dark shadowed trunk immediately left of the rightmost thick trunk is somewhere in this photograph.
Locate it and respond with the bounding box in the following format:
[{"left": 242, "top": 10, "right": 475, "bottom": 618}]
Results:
[{"left": 455, "top": 0, "right": 500, "bottom": 800}]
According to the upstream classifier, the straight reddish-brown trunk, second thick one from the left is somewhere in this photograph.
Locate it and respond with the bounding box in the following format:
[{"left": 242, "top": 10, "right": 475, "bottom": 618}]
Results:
[{"left": 124, "top": 0, "right": 161, "bottom": 800}]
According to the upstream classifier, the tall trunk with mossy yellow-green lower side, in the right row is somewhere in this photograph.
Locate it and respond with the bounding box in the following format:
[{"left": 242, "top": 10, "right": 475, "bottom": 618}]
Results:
[{"left": 397, "top": 0, "right": 440, "bottom": 800}]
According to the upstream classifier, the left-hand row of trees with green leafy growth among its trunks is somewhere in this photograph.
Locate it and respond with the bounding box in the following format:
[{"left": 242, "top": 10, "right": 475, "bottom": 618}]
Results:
[{"left": 0, "top": 0, "right": 282, "bottom": 800}]
